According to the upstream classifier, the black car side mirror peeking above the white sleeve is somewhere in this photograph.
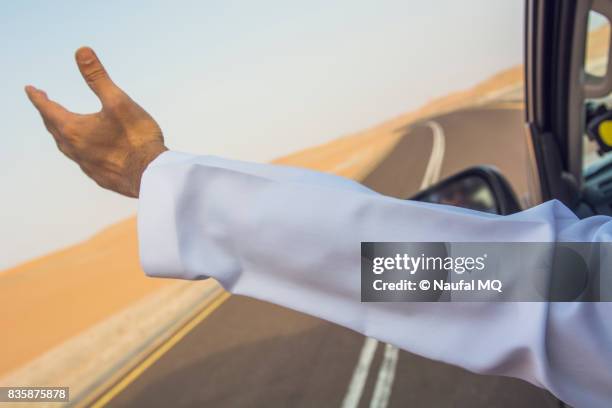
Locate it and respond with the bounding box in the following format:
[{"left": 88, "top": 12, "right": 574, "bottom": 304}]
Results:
[{"left": 411, "top": 166, "right": 521, "bottom": 215}]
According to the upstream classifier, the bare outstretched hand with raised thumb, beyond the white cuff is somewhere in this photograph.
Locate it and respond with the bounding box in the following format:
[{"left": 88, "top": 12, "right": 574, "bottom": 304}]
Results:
[{"left": 26, "top": 47, "right": 168, "bottom": 197}]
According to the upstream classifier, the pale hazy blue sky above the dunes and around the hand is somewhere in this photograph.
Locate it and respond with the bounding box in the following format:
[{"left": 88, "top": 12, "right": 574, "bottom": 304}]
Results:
[{"left": 0, "top": 0, "right": 524, "bottom": 269}]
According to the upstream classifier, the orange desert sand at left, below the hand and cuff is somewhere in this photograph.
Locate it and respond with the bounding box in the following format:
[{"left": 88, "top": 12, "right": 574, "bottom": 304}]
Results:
[{"left": 0, "top": 219, "right": 167, "bottom": 376}]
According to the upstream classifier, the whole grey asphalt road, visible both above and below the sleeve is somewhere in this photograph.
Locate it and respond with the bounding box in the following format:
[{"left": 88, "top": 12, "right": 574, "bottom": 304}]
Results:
[{"left": 98, "top": 108, "right": 558, "bottom": 408}]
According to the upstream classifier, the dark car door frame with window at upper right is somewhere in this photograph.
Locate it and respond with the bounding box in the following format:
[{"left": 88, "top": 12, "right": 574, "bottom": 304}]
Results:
[{"left": 525, "top": 0, "right": 612, "bottom": 217}]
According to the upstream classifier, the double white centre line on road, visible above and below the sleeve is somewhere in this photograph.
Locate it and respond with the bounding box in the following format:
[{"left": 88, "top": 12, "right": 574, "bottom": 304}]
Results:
[{"left": 342, "top": 121, "right": 446, "bottom": 408}]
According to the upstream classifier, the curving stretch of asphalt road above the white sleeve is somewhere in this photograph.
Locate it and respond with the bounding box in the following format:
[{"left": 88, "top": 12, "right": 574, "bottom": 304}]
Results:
[{"left": 362, "top": 107, "right": 528, "bottom": 198}]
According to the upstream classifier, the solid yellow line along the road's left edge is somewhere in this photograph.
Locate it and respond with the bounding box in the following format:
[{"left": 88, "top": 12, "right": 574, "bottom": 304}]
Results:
[{"left": 91, "top": 292, "right": 230, "bottom": 408}]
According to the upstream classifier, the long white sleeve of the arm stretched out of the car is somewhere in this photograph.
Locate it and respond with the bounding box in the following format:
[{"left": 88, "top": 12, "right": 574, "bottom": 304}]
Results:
[{"left": 138, "top": 152, "right": 612, "bottom": 407}]
